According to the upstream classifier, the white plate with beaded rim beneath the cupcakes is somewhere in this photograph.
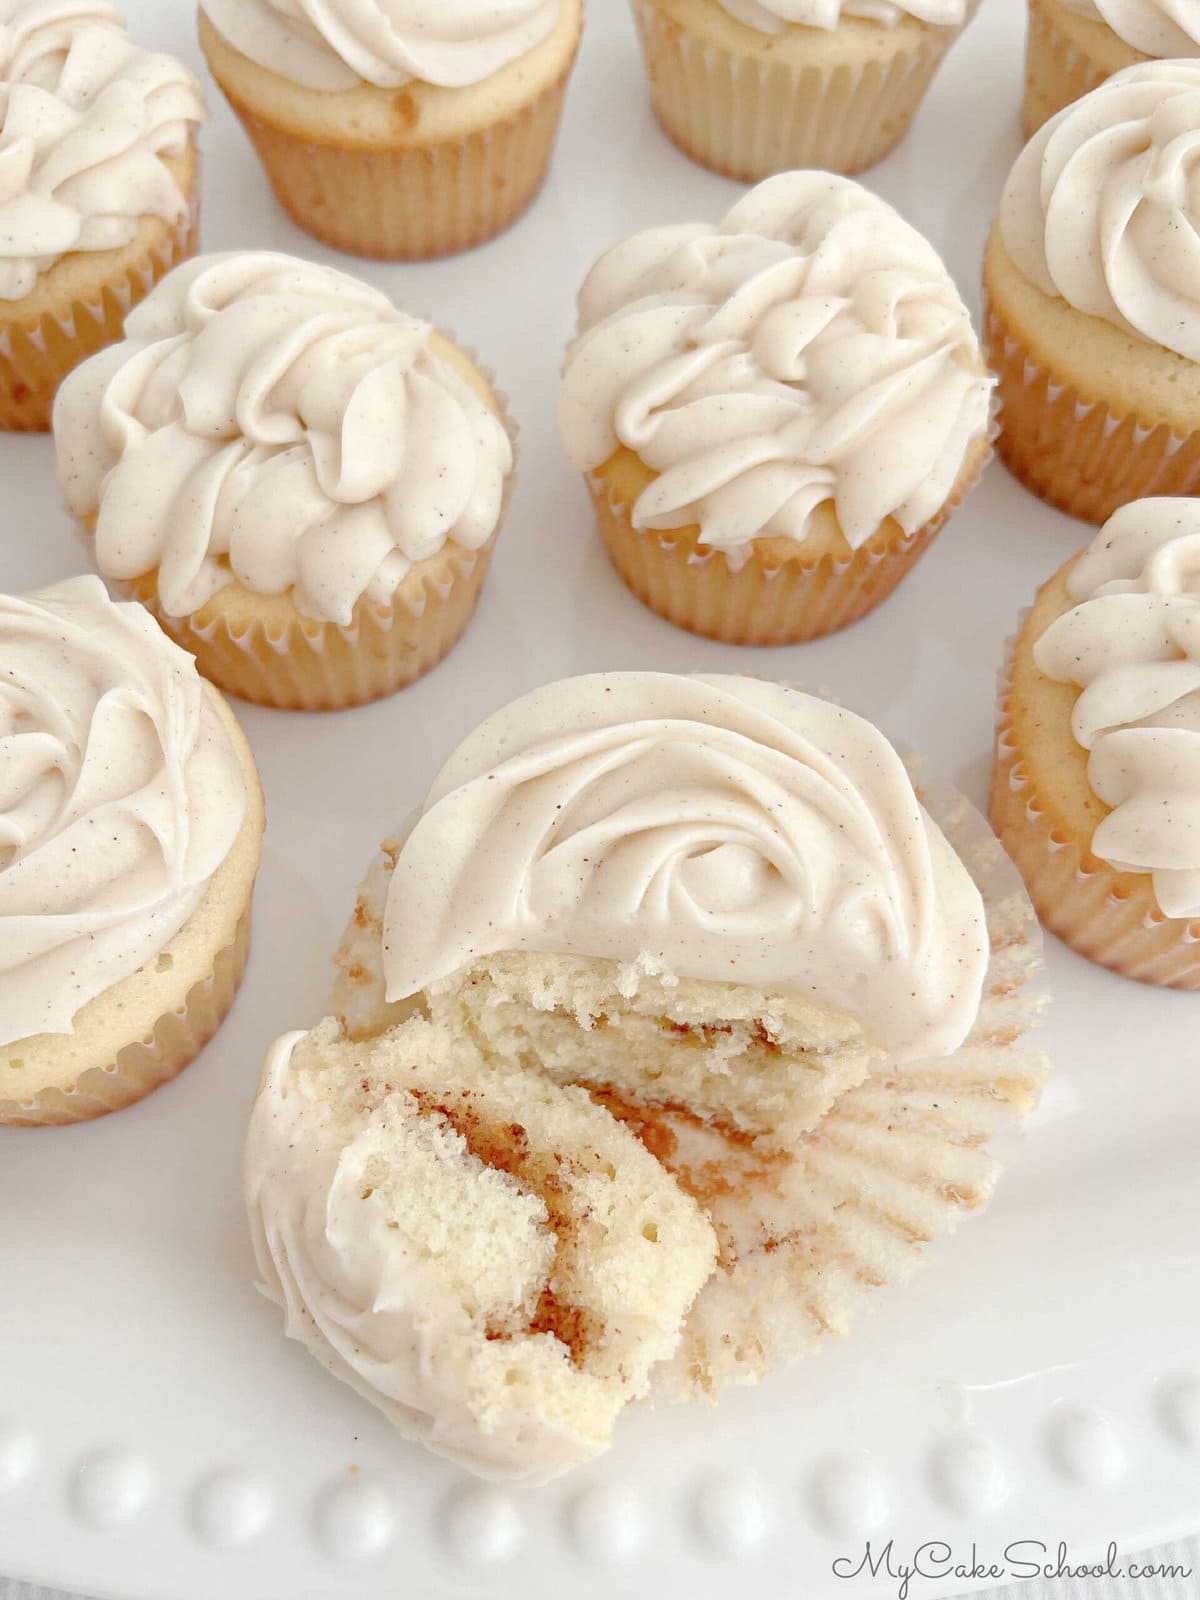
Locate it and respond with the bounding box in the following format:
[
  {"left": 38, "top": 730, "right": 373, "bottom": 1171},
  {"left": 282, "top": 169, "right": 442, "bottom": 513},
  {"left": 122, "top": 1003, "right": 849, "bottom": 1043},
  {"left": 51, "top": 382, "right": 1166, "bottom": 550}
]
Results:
[{"left": 0, "top": 0, "right": 1200, "bottom": 1600}]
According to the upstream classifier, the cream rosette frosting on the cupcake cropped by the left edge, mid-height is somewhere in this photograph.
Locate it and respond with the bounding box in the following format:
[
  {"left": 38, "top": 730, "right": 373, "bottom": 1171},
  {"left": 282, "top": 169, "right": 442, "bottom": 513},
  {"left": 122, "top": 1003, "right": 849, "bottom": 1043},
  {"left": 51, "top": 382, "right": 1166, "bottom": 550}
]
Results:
[{"left": 0, "top": 578, "right": 246, "bottom": 1045}]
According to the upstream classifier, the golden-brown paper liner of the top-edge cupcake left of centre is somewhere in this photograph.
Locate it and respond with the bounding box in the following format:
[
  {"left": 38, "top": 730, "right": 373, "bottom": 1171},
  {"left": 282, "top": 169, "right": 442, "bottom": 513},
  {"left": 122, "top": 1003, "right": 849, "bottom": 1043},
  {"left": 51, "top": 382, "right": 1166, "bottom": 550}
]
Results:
[{"left": 226, "top": 62, "right": 573, "bottom": 261}]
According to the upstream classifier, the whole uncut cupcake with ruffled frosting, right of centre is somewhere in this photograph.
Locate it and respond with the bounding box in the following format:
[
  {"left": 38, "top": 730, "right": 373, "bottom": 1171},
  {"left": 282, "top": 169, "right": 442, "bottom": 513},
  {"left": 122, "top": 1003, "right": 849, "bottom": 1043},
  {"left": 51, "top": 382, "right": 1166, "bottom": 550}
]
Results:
[{"left": 558, "top": 173, "right": 992, "bottom": 645}]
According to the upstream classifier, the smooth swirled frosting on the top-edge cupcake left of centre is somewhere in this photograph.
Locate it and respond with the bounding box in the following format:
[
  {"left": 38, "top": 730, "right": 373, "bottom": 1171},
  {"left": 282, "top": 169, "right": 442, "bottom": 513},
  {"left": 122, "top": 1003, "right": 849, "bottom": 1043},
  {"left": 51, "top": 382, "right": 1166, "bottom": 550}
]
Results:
[{"left": 202, "top": 0, "right": 562, "bottom": 90}]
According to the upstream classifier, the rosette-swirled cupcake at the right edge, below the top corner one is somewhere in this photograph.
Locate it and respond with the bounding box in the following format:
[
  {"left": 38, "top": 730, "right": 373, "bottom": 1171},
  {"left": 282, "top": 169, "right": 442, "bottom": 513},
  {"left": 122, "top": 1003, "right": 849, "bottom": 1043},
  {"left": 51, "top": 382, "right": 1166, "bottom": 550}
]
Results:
[{"left": 984, "top": 61, "right": 1200, "bottom": 523}]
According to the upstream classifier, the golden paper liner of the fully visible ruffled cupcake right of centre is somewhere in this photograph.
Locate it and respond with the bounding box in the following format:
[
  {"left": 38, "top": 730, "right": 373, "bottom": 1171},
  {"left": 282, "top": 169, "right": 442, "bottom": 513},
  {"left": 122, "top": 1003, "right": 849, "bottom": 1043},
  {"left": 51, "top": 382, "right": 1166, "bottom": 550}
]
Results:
[{"left": 587, "top": 448, "right": 990, "bottom": 645}]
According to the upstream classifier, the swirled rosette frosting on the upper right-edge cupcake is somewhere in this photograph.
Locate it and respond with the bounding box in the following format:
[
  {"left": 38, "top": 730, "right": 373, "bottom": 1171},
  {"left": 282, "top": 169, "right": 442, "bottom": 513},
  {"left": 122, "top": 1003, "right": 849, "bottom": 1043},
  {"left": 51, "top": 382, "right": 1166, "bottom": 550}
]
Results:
[{"left": 1000, "top": 61, "right": 1200, "bottom": 362}]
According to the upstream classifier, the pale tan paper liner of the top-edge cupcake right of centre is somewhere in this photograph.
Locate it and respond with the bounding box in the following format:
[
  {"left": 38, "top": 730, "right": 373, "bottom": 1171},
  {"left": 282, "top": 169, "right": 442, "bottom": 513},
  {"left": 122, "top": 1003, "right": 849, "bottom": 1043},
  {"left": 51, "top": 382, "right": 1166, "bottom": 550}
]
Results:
[{"left": 634, "top": 0, "right": 955, "bottom": 182}]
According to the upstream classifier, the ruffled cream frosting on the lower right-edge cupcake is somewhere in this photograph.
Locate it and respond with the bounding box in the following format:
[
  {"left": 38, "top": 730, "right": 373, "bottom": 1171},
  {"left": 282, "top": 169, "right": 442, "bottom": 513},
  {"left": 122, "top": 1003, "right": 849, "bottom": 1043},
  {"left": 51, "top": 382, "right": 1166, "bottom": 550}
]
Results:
[{"left": 1034, "top": 499, "right": 1200, "bottom": 917}]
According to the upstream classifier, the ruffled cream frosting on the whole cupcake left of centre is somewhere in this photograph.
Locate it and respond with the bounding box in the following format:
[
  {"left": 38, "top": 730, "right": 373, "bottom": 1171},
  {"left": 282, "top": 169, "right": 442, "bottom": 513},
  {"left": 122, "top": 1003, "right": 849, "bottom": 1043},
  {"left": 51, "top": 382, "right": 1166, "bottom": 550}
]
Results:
[{"left": 54, "top": 253, "right": 512, "bottom": 624}]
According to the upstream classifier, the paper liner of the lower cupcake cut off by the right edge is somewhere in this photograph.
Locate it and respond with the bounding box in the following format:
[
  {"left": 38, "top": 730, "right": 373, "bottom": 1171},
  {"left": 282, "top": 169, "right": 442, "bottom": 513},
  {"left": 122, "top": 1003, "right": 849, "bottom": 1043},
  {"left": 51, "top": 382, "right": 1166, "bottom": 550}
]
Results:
[{"left": 989, "top": 633, "right": 1200, "bottom": 989}]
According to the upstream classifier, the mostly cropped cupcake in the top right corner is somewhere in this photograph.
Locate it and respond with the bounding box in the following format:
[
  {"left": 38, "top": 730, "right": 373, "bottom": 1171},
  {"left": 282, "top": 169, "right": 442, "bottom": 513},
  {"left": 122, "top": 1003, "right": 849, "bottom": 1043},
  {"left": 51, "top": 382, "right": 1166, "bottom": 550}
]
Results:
[{"left": 1021, "top": 0, "right": 1200, "bottom": 139}]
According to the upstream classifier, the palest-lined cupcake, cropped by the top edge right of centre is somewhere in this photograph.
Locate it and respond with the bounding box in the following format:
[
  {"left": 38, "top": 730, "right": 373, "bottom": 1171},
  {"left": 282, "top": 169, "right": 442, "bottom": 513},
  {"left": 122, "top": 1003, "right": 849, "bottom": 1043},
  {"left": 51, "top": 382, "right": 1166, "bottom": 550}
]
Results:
[{"left": 632, "top": 0, "right": 978, "bottom": 182}]
